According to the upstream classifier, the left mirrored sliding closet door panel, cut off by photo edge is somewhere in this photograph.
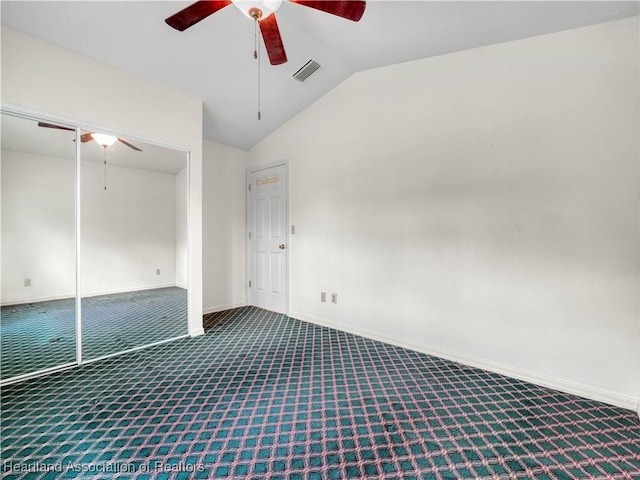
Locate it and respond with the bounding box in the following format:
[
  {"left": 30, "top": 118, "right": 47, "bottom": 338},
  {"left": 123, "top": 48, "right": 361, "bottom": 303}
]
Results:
[{"left": 0, "top": 113, "right": 76, "bottom": 380}]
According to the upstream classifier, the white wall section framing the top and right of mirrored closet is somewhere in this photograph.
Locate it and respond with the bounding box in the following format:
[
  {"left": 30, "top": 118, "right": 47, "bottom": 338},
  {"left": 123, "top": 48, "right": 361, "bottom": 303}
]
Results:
[{"left": 1, "top": 26, "right": 204, "bottom": 335}]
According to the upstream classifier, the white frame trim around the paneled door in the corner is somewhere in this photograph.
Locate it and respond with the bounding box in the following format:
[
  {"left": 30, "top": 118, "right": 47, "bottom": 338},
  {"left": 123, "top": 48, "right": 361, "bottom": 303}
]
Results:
[{"left": 245, "top": 160, "right": 291, "bottom": 315}]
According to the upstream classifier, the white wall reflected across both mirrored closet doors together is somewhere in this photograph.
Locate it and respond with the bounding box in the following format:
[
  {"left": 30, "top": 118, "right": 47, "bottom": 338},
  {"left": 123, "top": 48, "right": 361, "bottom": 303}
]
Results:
[{"left": 1, "top": 150, "right": 186, "bottom": 304}]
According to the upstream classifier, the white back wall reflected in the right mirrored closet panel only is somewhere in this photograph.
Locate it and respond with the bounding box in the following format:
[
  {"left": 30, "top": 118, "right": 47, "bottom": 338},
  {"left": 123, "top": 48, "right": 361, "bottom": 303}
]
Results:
[{"left": 80, "top": 162, "right": 176, "bottom": 296}]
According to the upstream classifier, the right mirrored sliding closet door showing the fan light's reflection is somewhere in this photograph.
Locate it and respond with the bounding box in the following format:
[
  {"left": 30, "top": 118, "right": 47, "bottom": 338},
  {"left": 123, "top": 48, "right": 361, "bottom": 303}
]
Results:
[{"left": 80, "top": 131, "right": 188, "bottom": 361}]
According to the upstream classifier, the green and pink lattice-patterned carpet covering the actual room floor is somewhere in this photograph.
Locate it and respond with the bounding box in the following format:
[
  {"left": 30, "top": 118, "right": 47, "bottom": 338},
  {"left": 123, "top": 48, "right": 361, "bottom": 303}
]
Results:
[{"left": 2, "top": 307, "right": 640, "bottom": 480}]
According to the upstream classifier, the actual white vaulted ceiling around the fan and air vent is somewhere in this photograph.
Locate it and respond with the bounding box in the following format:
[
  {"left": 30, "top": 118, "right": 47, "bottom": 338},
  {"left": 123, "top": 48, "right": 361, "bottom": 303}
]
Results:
[{"left": 1, "top": 0, "right": 639, "bottom": 149}]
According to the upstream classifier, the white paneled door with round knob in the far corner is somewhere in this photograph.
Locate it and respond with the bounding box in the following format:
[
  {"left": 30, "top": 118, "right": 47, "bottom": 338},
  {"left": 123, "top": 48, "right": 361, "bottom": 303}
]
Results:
[{"left": 247, "top": 165, "right": 289, "bottom": 313}]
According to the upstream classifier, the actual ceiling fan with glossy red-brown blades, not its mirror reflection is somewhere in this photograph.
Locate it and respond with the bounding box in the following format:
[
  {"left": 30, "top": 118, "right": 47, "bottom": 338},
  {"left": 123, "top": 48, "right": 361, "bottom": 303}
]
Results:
[{"left": 165, "top": 0, "right": 366, "bottom": 65}]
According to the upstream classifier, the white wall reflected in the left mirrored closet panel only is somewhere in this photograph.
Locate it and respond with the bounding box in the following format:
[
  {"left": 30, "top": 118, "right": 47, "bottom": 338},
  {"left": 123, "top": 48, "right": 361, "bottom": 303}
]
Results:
[{"left": 0, "top": 150, "right": 76, "bottom": 305}]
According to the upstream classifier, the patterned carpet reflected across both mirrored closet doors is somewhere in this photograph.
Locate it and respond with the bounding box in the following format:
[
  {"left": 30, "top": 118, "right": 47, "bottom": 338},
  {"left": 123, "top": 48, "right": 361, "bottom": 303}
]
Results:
[{"left": 0, "top": 287, "right": 187, "bottom": 379}]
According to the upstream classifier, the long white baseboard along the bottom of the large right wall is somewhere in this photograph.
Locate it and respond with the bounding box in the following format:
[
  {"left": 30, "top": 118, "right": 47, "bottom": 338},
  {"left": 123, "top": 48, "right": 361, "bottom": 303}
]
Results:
[{"left": 290, "top": 312, "right": 640, "bottom": 415}]
